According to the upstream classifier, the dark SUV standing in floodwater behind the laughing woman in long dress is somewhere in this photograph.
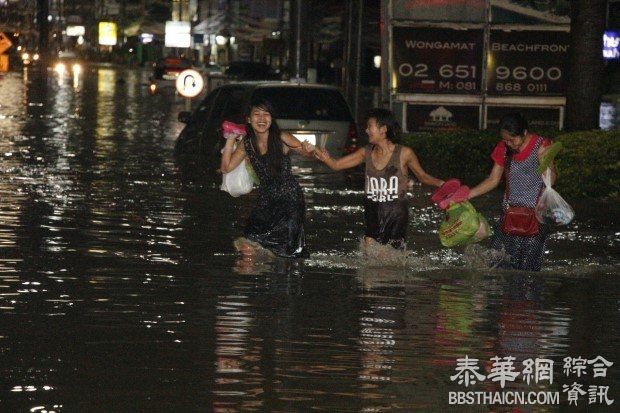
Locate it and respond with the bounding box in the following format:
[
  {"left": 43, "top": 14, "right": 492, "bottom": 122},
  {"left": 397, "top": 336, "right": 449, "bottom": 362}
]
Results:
[{"left": 176, "top": 82, "right": 358, "bottom": 167}]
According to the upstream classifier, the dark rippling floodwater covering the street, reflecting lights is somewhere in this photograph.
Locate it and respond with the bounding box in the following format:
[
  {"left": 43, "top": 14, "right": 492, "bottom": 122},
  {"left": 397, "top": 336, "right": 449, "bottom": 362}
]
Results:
[{"left": 0, "top": 66, "right": 620, "bottom": 412}]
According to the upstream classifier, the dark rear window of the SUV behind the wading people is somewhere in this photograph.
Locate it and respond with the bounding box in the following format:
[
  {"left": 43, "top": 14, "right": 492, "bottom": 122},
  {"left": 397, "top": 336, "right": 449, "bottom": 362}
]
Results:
[{"left": 253, "top": 87, "right": 351, "bottom": 122}]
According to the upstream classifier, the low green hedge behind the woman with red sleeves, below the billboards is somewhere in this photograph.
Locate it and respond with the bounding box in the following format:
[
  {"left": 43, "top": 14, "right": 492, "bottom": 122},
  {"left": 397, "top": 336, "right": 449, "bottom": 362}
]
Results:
[{"left": 403, "top": 130, "right": 620, "bottom": 198}]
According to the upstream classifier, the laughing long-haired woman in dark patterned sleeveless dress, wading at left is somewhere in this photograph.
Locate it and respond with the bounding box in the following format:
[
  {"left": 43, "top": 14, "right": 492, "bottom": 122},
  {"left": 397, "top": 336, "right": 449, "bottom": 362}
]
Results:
[{"left": 221, "top": 100, "right": 311, "bottom": 258}]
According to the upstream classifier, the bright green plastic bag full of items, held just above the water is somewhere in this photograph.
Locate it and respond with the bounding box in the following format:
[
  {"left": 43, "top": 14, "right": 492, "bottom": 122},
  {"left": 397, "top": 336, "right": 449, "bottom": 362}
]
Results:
[{"left": 439, "top": 201, "right": 490, "bottom": 247}]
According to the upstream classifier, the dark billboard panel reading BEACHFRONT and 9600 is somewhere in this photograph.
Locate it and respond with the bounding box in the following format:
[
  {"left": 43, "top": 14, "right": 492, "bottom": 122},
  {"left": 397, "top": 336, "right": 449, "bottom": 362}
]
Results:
[{"left": 487, "top": 30, "right": 569, "bottom": 96}]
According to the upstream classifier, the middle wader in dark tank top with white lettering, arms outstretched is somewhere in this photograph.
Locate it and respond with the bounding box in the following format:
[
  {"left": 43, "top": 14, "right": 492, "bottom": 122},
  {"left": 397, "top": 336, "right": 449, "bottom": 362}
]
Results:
[{"left": 306, "top": 109, "right": 443, "bottom": 248}]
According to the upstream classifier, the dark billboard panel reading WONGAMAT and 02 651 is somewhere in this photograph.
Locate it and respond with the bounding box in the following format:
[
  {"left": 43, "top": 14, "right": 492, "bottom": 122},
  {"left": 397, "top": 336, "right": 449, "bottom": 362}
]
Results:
[{"left": 392, "top": 27, "right": 483, "bottom": 94}]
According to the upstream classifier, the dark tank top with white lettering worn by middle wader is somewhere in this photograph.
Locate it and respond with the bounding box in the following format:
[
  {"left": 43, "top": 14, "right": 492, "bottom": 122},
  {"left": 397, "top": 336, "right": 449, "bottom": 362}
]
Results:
[{"left": 365, "top": 144, "right": 407, "bottom": 202}]
